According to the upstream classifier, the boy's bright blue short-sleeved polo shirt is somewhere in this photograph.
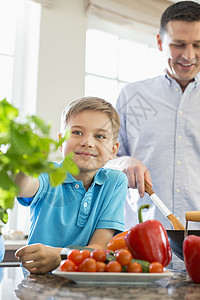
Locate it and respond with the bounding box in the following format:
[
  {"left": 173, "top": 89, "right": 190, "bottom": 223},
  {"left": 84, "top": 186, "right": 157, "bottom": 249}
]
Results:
[{"left": 17, "top": 168, "right": 127, "bottom": 247}]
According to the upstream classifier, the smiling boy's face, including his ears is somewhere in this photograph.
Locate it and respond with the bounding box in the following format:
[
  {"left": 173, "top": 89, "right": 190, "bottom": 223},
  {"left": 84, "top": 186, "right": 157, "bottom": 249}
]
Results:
[{"left": 62, "top": 111, "right": 119, "bottom": 173}]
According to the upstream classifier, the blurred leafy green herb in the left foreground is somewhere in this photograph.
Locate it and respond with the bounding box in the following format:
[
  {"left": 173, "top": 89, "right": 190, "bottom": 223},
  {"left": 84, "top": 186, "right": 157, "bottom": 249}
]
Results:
[{"left": 0, "top": 99, "right": 79, "bottom": 223}]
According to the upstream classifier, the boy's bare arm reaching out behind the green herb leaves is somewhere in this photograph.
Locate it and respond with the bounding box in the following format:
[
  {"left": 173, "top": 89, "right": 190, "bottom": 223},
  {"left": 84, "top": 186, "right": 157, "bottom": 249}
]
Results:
[{"left": 15, "top": 172, "right": 39, "bottom": 198}]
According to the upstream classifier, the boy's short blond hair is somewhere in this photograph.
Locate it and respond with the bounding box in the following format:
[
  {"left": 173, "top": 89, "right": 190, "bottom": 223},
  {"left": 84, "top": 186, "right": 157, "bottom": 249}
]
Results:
[{"left": 61, "top": 97, "right": 120, "bottom": 140}]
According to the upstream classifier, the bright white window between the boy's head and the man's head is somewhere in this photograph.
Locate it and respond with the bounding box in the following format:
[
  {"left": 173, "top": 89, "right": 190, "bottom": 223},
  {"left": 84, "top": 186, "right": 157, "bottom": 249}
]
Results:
[{"left": 85, "top": 29, "right": 164, "bottom": 106}]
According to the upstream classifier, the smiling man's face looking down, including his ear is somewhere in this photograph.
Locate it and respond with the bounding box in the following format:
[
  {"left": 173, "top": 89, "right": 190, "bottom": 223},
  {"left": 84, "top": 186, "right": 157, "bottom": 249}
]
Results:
[{"left": 157, "top": 20, "right": 200, "bottom": 88}]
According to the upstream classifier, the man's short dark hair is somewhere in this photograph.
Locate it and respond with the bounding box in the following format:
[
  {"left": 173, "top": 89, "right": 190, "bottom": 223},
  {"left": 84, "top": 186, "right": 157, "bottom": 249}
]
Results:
[{"left": 160, "top": 1, "right": 200, "bottom": 35}]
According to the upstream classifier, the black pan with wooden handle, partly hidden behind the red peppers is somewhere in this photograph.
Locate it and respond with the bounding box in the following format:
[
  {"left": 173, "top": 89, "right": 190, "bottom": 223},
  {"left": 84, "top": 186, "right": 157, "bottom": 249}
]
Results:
[{"left": 166, "top": 211, "right": 200, "bottom": 260}]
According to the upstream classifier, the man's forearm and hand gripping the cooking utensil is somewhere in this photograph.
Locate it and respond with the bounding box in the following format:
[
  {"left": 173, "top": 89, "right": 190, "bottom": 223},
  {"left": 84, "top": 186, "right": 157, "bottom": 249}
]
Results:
[{"left": 105, "top": 156, "right": 152, "bottom": 197}]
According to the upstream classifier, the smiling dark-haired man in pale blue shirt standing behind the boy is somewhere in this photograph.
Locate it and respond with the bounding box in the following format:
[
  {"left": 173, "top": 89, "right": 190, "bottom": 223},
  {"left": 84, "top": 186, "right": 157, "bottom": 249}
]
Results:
[{"left": 109, "top": 1, "right": 200, "bottom": 229}]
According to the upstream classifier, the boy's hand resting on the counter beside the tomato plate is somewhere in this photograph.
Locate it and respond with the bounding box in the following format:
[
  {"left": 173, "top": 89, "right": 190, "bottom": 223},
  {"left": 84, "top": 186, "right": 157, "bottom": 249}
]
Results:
[{"left": 15, "top": 244, "right": 62, "bottom": 274}]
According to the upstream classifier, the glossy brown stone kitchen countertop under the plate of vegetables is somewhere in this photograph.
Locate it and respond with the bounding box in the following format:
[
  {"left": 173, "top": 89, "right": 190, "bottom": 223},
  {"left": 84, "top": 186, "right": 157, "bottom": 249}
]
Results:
[{"left": 0, "top": 262, "right": 200, "bottom": 300}]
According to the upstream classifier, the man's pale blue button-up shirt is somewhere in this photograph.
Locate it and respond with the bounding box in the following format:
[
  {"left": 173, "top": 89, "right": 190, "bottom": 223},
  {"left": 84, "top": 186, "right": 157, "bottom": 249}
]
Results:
[{"left": 117, "top": 71, "right": 200, "bottom": 229}]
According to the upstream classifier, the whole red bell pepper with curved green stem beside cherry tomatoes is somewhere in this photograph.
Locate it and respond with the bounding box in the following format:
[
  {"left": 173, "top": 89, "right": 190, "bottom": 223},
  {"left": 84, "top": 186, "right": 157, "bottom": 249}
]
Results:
[{"left": 125, "top": 204, "right": 172, "bottom": 267}]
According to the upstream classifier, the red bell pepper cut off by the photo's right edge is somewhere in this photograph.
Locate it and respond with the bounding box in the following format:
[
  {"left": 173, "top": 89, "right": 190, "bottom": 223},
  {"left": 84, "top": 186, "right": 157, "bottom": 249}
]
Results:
[{"left": 183, "top": 235, "right": 200, "bottom": 283}]
